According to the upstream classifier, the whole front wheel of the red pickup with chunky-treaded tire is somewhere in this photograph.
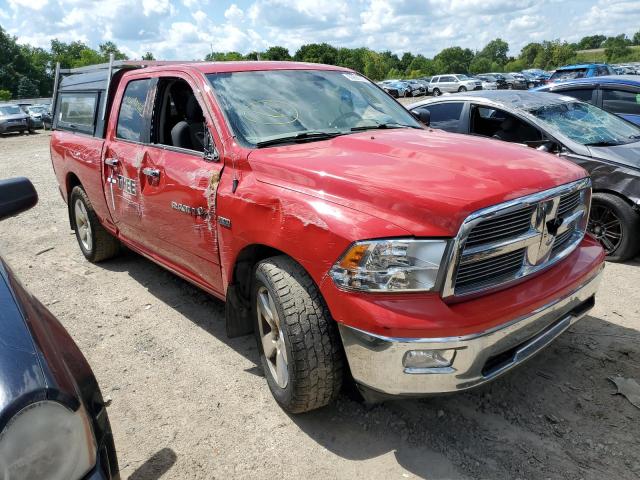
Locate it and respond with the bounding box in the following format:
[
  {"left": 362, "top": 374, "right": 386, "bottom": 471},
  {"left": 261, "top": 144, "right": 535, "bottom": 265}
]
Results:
[{"left": 251, "top": 256, "right": 345, "bottom": 413}]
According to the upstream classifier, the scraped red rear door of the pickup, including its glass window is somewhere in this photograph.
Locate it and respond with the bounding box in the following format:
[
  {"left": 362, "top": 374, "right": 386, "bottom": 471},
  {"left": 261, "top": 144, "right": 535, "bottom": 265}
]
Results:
[{"left": 102, "top": 75, "right": 155, "bottom": 243}]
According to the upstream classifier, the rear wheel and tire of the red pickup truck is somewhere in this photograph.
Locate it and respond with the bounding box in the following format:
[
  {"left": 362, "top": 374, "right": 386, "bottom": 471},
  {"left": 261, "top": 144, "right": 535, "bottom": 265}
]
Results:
[{"left": 69, "top": 186, "right": 120, "bottom": 263}]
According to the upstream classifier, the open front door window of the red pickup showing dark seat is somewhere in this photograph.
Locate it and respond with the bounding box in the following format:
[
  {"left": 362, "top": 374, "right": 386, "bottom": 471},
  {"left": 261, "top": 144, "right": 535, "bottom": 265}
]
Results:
[{"left": 151, "top": 78, "right": 207, "bottom": 153}]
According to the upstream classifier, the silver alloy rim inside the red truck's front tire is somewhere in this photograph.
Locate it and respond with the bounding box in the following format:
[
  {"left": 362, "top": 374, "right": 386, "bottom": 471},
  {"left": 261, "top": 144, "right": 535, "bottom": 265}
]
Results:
[{"left": 256, "top": 286, "right": 289, "bottom": 388}]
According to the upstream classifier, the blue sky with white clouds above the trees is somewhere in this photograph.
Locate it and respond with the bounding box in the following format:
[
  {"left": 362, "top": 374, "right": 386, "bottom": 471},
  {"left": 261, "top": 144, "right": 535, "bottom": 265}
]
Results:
[{"left": 0, "top": 0, "right": 640, "bottom": 60}]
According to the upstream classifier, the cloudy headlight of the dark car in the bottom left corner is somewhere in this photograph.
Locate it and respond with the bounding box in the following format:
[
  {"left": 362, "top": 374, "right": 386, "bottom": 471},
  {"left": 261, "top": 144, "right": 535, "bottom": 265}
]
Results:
[{"left": 0, "top": 401, "right": 96, "bottom": 480}]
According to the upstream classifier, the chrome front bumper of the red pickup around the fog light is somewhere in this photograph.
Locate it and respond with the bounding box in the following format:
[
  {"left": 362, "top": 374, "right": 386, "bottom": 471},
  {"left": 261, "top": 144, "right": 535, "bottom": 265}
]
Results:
[{"left": 339, "top": 270, "right": 602, "bottom": 395}]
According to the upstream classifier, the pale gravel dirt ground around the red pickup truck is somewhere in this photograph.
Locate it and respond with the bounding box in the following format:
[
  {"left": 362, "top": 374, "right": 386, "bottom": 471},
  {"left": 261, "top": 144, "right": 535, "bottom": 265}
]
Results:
[{"left": 0, "top": 129, "right": 640, "bottom": 480}]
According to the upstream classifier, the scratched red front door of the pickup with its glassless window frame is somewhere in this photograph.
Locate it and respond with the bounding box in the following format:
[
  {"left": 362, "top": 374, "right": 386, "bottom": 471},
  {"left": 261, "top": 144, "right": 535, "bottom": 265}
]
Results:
[{"left": 140, "top": 72, "right": 223, "bottom": 292}]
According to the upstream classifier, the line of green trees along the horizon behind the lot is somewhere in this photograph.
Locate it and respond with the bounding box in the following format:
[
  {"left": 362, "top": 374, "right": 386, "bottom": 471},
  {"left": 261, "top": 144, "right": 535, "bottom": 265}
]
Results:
[{"left": 0, "top": 26, "right": 640, "bottom": 100}]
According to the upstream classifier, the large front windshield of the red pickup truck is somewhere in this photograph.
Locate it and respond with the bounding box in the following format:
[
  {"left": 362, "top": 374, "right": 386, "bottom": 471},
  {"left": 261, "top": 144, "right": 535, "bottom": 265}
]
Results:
[{"left": 207, "top": 70, "right": 421, "bottom": 146}]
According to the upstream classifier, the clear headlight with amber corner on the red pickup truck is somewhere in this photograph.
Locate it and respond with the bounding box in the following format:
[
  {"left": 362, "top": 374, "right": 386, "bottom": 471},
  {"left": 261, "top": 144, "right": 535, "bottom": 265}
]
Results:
[{"left": 329, "top": 239, "right": 447, "bottom": 292}]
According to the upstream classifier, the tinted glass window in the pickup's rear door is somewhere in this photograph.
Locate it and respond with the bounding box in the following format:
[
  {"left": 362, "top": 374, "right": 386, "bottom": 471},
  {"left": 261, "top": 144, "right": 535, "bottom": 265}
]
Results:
[{"left": 116, "top": 78, "right": 152, "bottom": 142}]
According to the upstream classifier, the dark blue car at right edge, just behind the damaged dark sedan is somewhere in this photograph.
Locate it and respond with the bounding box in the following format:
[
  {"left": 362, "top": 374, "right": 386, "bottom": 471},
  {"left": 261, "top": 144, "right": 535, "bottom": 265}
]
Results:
[{"left": 536, "top": 75, "right": 640, "bottom": 125}]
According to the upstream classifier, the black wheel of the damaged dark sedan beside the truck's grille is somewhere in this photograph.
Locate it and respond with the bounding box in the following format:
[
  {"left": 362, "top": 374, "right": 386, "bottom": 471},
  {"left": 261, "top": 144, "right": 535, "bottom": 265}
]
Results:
[{"left": 587, "top": 193, "right": 640, "bottom": 262}]
